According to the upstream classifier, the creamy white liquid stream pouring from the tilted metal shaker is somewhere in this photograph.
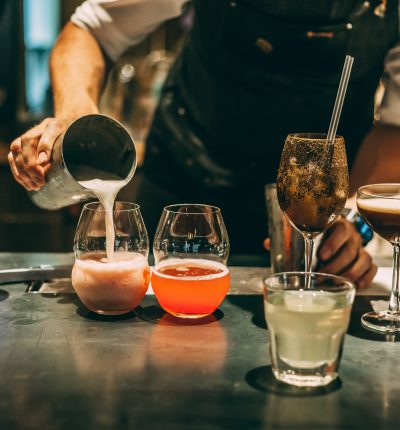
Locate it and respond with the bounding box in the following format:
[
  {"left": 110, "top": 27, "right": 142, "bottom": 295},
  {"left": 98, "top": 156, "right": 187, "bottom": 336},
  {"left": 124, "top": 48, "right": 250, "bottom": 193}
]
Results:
[{"left": 79, "top": 179, "right": 126, "bottom": 261}]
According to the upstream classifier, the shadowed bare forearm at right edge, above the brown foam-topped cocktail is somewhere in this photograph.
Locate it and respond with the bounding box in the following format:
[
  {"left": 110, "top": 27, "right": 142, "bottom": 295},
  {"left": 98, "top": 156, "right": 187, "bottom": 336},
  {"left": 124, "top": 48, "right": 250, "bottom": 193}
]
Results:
[{"left": 350, "top": 125, "right": 400, "bottom": 196}]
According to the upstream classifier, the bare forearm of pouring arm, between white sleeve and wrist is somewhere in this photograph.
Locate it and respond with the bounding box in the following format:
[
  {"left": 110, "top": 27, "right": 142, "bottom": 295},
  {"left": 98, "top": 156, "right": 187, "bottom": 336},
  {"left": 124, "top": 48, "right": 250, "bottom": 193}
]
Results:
[{"left": 50, "top": 22, "right": 106, "bottom": 119}]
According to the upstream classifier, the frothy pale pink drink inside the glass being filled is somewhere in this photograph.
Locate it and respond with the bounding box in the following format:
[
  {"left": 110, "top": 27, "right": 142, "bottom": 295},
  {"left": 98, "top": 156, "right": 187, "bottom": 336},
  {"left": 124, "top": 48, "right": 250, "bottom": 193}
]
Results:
[{"left": 72, "top": 252, "right": 150, "bottom": 315}]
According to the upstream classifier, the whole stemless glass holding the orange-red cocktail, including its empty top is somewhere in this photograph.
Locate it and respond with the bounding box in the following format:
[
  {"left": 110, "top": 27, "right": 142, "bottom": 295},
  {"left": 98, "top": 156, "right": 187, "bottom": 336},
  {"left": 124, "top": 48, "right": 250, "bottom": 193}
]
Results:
[{"left": 151, "top": 204, "right": 230, "bottom": 318}]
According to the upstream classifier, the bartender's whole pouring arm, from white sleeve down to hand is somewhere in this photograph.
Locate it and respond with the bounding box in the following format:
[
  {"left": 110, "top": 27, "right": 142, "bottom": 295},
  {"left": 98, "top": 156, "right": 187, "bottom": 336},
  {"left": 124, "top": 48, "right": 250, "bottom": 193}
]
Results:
[{"left": 8, "top": 0, "right": 186, "bottom": 190}]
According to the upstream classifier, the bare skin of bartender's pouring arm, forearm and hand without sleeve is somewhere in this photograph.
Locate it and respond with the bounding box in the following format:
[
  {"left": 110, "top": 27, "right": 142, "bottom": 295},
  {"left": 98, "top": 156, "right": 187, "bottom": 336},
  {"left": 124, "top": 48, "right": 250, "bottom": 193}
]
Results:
[{"left": 8, "top": 22, "right": 105, "bottom": 190}]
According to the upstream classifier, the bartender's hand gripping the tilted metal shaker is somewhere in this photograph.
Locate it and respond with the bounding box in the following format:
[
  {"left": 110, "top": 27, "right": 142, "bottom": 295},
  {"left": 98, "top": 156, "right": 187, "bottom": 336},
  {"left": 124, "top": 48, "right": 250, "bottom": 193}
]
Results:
[{"left": 8, "top": 118, "right": 71, "bottom": 191}]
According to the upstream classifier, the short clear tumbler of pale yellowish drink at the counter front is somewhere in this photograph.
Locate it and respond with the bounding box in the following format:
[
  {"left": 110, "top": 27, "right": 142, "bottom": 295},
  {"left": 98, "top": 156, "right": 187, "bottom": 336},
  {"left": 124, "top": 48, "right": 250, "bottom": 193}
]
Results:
[{"left": 264, "top": 273, "right": 354, "bottom": 386}]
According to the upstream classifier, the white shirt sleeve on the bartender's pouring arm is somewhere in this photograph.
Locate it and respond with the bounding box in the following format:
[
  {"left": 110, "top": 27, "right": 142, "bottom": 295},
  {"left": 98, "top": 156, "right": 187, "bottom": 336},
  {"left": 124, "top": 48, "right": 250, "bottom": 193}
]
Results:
[{"left": 71, "top": 0, "right": 187, "bottom": 60}]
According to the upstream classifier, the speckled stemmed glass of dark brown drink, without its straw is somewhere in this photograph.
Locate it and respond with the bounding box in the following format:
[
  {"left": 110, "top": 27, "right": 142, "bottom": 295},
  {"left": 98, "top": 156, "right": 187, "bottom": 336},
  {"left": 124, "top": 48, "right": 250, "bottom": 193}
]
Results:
[{"left": 277, "top": 133, "right": 349, "bottom": 273}]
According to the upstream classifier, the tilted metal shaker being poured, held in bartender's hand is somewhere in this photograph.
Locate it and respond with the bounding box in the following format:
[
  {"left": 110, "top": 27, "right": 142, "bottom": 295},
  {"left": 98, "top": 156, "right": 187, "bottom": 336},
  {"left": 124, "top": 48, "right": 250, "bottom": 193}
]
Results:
[{"left": 29, "top": 114, "right": 136, "bottom": 209}]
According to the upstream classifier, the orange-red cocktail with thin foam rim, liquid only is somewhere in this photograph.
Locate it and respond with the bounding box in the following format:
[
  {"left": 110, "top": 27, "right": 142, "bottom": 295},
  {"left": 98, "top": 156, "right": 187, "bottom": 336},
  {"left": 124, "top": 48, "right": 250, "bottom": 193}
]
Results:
[{"left": 151, "top": 258, "right": 230, "bottom": 318}]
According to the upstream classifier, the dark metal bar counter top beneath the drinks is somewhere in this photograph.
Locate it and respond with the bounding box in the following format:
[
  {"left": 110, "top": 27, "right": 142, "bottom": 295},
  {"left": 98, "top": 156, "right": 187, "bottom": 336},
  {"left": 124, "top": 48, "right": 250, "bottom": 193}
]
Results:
[{"left": 0, "top": 254, "right": 400, "bottom": 430}]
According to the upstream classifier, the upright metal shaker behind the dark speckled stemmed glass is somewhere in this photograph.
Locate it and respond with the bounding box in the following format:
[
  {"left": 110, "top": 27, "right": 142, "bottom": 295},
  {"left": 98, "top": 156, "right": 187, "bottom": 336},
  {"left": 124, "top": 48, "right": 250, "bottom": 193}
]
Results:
[{"left": 265, "top": 184, "right": 304, "bottom": 273}]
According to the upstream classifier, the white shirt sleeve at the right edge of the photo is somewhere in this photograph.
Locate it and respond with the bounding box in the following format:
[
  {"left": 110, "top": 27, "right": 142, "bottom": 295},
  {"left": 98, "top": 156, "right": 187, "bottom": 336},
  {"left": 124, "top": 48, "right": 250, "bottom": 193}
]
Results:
[{"left": 376, "top": 43, "right": 400, "bottom": 126}]
